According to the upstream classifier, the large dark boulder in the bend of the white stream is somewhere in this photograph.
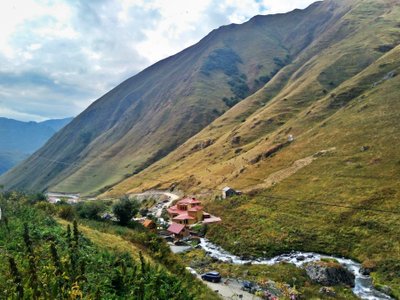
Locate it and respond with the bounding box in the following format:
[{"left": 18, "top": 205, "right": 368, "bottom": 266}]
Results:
[{"left": 305, "top": 261, "right": 355, "bottom": 287}]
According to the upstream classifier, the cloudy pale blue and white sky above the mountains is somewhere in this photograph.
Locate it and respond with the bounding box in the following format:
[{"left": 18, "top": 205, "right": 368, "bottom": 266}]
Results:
[{"left": 0, "top": 0, "right": 314, "bottom": 121}]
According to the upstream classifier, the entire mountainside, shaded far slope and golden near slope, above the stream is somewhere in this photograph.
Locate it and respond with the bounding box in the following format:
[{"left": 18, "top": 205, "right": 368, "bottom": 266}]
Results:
[{"left": 0, "top": 0, "right": 400, "bottom": 299}]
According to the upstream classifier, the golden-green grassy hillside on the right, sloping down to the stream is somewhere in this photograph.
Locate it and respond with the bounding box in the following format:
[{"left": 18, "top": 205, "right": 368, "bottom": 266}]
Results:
[{"left": 104, "top": 0, "right": 400, "bottom": 298}]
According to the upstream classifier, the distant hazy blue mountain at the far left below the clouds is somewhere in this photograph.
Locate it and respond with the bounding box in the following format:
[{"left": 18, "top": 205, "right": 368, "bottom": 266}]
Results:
[{"left": 0, "top": 118, "right": 72, "bottom": 174}]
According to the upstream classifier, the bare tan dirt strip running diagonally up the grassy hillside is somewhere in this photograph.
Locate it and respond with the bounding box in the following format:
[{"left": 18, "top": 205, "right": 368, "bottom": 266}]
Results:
[{"left": 244, "top": 148, "right": 336, "bottom": 192}]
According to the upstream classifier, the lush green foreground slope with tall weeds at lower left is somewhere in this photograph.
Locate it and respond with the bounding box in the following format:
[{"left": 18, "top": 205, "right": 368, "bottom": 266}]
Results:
[{"left": 0, "top": 193, "right": 217, "bottom": 299}]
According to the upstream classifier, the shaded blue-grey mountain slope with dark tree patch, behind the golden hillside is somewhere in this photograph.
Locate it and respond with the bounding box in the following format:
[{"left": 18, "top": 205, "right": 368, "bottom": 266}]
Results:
[{"left": 0, "top": 1, "right": 349, "bottom": 194}]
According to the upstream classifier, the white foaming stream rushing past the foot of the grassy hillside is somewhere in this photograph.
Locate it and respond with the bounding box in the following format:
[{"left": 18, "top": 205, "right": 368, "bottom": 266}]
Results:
[{"left": 200, "top": 239, "right": 393, "bottom": 300}]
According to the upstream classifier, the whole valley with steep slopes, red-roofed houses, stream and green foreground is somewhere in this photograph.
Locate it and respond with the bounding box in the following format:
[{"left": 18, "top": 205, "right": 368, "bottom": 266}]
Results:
[{"left": 0, "top": 0, "right": 400, "bottom": 300}]
